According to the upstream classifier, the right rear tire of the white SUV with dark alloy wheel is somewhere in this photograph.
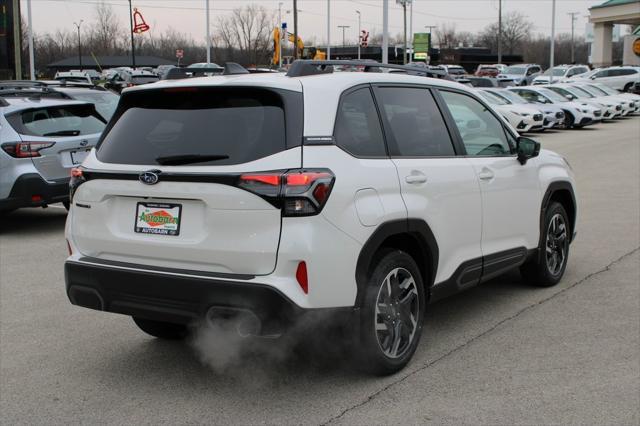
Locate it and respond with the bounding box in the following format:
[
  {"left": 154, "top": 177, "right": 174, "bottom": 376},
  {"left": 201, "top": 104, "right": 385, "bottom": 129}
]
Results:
[{"left": 354, "top": 250, "right": 427, "bottom": 375}]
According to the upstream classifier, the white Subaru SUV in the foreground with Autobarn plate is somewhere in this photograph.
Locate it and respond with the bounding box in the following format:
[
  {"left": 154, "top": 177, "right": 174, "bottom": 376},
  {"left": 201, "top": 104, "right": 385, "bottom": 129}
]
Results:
[{"left": 65, "top": 61, "right": 578, "bottom": 374}]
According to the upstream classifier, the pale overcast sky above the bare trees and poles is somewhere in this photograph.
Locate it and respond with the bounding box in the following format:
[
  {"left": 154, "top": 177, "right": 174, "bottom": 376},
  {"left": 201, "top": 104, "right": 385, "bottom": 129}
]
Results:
[{"left": 22, "top": 0, "right": 604, "bottom": 43}]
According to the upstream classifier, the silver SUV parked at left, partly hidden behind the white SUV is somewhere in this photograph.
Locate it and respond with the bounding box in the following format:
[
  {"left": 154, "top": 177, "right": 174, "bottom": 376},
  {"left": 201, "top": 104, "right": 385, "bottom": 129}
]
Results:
[{"left": 0, "top": 97, "right": 106, "bottom": 212}]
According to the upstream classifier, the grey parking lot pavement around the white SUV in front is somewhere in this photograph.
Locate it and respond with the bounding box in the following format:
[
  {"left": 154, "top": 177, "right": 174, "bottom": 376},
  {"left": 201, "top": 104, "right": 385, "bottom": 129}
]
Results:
[{"left": 0, "top": 117, "right": 640, "bottom": 424}]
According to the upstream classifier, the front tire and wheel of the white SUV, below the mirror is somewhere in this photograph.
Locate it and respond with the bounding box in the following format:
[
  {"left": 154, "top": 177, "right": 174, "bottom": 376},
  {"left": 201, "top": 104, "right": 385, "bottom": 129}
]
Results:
[{"left": 520, "top": 201, "right": 571, "bottom": 287}]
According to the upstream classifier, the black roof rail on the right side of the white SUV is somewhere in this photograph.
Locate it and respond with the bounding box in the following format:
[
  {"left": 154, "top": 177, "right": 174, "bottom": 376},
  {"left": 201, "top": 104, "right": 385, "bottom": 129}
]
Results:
[{"left": 287, "top": 59, "right": 447, "bottom": 78}]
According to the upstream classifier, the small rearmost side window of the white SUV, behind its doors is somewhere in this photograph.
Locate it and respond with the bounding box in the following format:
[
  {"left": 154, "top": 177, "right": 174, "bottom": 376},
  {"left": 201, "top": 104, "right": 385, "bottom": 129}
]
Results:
[{"left": 335, "top": 88, "right": 387, "bottom": 157}]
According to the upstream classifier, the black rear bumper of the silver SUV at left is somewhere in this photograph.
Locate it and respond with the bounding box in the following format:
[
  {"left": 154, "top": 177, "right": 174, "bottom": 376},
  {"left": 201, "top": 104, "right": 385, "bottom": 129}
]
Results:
[{"left": 0, "top": 173, "right": 69, "bottom": 211}]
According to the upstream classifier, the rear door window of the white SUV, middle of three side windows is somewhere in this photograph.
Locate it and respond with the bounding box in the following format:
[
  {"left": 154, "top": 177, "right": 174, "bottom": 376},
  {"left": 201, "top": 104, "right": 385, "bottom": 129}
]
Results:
[{"left": 379, "top": 87, "right": 455, "bottom": 157}]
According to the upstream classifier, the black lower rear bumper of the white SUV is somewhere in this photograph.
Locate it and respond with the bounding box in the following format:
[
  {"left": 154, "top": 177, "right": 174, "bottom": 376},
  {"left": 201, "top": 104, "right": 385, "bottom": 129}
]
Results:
[{"left": 64, "top": 261, "right": 354, "bottom": 334}]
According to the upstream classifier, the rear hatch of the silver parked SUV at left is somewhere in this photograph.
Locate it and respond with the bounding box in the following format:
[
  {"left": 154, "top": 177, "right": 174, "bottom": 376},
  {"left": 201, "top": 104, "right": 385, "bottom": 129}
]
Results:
[{"left": 6, "top": 104, "right": 106, "bottom": 181}]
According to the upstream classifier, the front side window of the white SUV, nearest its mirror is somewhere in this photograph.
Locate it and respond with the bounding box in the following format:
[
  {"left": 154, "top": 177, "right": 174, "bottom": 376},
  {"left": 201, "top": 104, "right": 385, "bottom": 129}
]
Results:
[{"left": 442, "top": 91, "right": 511, "bottom": 156}]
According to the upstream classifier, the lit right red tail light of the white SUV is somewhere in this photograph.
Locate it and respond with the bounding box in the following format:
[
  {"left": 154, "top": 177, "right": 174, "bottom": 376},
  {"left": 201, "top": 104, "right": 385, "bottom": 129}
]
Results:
[{"left": 238, "top": 169, "right": 335, "bottom": 216}]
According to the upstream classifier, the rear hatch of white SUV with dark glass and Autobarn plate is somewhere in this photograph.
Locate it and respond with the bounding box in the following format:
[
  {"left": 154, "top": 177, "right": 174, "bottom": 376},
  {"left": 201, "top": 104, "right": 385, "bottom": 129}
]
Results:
[{"left": 71, "top": 87, "right": 302, "bottom": 275}]
